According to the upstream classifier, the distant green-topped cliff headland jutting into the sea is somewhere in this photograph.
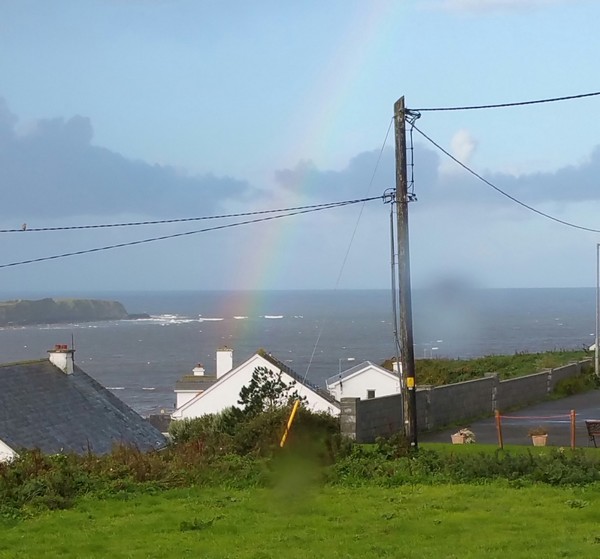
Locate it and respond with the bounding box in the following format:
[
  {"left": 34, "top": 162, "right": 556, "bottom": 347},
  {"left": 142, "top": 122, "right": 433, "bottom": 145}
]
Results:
[{"left": 0, "top": 299, "right": 147, "bottom": 326}]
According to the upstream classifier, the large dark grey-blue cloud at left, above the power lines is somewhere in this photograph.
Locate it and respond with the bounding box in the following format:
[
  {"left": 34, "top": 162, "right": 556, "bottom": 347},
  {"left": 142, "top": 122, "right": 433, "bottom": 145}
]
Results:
[{"left": 0, "top": 100, "right": 252, "bottom": 222}]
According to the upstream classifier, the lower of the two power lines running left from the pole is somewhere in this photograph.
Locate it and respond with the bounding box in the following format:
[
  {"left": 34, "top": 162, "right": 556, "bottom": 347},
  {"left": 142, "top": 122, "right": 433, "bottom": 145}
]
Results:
[{"left": 0, "top": 196, "right": 382, "bottom": 268}]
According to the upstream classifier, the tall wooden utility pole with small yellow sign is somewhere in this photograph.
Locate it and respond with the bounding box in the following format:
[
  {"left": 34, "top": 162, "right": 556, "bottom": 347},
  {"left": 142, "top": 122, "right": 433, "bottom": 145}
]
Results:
[{"left": 394, "top": 97, "right": 418, "bottom": 450}]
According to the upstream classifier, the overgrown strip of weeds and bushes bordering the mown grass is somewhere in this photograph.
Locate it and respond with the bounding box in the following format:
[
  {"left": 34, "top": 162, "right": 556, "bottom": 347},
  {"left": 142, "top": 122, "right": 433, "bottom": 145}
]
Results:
[{"left": 0, "top": 410, "right": 600, "bottom": 520}]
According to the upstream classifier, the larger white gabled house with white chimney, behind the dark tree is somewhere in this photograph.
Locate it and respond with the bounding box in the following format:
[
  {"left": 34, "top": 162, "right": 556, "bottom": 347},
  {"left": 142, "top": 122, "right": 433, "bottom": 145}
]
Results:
[{"left": 171, "top": 348, "right": 340, "bottom": 420}]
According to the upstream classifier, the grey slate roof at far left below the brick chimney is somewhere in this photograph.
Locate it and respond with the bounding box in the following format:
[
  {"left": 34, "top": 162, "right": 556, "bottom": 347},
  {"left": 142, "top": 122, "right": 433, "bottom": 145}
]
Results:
[{"left": 0, "top": 359, "right": 166, "bottom": 454}]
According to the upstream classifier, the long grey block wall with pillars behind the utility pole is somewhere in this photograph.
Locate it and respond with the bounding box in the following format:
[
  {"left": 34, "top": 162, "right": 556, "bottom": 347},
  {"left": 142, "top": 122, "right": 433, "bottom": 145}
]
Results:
[{"left": 340, "top": 359, "right": 591, "bottom": 443}]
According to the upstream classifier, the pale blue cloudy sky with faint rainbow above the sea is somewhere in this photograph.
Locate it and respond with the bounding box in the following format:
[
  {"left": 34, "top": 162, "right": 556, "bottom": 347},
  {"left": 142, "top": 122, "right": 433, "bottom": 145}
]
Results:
[{"left": 0, "top": 0, "right": 600, "bottom": 296}]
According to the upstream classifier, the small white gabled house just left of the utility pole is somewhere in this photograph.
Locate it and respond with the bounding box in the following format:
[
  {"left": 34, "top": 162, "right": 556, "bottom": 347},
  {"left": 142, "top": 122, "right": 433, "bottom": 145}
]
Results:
[{"left": 326, "top": 361, "right": 400, "bottom": 401}]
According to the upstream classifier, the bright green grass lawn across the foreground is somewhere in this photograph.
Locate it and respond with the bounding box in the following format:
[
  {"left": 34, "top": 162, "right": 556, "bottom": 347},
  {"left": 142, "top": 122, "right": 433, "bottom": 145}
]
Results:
[{"left": 0, "top": 482, "right": 600, "bottom": 559}]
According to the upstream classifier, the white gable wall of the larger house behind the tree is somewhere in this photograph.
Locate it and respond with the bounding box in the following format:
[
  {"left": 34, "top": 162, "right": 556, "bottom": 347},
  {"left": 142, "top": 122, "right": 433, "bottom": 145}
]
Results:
[{"left": 172, "top": 354, "right": 340, "bottom": 419}]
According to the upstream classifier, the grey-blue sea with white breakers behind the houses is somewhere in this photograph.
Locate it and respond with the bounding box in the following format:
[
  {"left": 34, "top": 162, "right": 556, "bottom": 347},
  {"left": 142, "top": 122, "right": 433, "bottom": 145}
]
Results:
[{"left": 0, "top": 286, "right": 596, "bottom": 416}]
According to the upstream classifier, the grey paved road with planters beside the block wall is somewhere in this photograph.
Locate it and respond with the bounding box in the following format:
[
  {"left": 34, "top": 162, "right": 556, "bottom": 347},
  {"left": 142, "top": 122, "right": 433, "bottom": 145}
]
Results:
[{"left": 419, "top": 390, "right": 600, "bottom": 447}]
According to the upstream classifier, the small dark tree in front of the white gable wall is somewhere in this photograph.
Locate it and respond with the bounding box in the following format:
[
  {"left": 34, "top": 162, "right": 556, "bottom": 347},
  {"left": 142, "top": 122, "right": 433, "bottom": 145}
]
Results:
[{"left": 238, "top": 367, "right": 306, "bottom": 415}]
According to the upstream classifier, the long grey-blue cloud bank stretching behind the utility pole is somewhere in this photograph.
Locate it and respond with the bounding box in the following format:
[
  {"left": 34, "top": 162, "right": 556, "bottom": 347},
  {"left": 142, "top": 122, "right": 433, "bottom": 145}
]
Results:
[{"left": 276, "top": 139, "right": 600, "bottom": 215}]
